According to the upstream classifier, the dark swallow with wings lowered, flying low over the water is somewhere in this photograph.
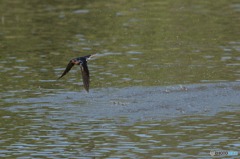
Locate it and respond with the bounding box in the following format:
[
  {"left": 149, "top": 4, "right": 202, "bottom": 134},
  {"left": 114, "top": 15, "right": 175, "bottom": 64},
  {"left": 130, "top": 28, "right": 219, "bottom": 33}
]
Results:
[{"left": 58, "top": 53, "right": 98, "bottom": 93}]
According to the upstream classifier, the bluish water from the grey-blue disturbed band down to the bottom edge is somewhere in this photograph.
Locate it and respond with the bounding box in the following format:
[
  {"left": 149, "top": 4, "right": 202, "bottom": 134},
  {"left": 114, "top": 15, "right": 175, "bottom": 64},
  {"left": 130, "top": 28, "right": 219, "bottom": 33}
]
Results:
[{"left": 0, "top": 83, "right": 240, "bottom": 158}]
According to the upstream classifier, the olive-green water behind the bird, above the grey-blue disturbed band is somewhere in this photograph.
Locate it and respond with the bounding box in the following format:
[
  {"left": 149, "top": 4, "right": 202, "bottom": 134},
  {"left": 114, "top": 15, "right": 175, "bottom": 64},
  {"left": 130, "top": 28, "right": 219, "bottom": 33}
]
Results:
[{"left": 0, "top": 1, "right": 240, "bottom": 94}]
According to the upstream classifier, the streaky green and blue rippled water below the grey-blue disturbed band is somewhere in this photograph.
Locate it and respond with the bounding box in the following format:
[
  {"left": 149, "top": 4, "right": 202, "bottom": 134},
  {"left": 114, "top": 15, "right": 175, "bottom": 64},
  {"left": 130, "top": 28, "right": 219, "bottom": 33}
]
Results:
[{"left": 0, "top": 100, "right": 239, "bottom": 158}]
